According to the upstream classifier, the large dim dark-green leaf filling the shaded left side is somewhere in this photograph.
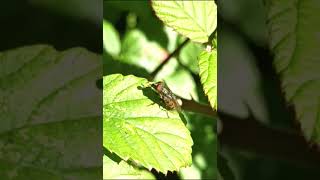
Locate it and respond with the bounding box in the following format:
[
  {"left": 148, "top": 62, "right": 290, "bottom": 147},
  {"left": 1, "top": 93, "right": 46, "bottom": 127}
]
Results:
[{"left": 0, "top": 45, "right": 102, "bottom": 180}]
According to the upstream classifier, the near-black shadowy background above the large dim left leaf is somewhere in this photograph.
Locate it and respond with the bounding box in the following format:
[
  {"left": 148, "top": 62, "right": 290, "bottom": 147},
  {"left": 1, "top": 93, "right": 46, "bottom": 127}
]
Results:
[{"left": 0, "top": 0, "right": 102, "bottom": 53}]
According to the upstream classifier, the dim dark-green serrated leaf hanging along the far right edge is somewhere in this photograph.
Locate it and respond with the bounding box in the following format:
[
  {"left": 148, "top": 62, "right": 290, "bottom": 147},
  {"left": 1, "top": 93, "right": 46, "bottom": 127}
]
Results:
[{"left": 268, "top": 0, "right": 320, "bottom": 144}]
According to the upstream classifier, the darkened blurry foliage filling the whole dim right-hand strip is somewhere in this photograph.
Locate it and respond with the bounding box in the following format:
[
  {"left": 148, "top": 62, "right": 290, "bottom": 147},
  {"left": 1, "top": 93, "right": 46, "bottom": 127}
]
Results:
[{"left": 218, "top": 0, "right": 319, "bottom": 180}]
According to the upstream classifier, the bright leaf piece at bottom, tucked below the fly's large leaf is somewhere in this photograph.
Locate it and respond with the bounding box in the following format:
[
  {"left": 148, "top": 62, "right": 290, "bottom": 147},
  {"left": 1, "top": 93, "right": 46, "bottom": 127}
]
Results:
[{"left": 103, "top": 156, "right": 155, "bottom": 180}]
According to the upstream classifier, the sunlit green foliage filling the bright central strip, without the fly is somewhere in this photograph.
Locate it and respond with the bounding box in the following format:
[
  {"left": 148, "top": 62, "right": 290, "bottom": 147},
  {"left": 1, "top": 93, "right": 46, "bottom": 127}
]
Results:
[{"left": 103, "top": 1, "right": 217, "bottom": 179}]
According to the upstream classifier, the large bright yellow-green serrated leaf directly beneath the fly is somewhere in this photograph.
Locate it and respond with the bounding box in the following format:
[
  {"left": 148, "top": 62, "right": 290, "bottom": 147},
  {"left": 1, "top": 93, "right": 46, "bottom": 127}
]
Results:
[{"left": 103, "top": 74, "right": 193, "bottom": 173}]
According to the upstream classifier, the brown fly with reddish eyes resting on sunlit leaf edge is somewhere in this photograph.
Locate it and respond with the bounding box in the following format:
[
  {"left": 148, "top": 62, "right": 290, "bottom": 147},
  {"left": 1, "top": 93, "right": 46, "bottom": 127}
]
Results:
[{"left": 151, "top": 81, "right": 181, "bottom": 111}]
